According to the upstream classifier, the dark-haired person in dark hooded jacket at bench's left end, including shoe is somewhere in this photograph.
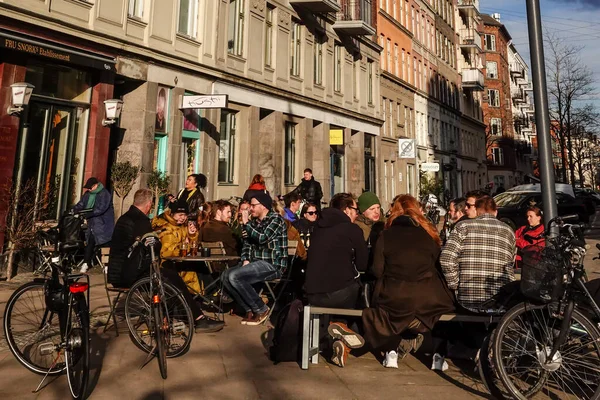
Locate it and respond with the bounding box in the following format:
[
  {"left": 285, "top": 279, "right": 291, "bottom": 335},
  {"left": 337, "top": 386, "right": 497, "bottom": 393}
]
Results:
[{"left": 305, "top": 193, "right": 368, "bottom": 367}]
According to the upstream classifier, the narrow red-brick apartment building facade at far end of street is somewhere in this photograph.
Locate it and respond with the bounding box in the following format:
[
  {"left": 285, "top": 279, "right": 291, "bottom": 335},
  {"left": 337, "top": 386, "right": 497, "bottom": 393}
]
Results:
[{"left": 482, "top": 14, "right": 520, "bottom": 191}]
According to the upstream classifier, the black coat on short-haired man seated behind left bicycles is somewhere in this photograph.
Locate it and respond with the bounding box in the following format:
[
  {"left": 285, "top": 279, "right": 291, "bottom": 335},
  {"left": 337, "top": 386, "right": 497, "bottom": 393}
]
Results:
[{"left": 107, "top": 206, "right": 152, "bottom": 288}]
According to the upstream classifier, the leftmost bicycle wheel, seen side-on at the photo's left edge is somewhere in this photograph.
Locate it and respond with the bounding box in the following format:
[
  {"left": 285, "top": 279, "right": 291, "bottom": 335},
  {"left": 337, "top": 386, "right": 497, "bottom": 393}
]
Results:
[{"left": 4, "top": 281, "right": 66, "bottom": 375}]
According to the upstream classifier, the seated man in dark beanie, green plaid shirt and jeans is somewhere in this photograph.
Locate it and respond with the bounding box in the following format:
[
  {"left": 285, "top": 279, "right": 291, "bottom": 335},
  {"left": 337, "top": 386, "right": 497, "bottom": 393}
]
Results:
[{"left": 222, "top": 192, "right": 288, "bottom": 325}]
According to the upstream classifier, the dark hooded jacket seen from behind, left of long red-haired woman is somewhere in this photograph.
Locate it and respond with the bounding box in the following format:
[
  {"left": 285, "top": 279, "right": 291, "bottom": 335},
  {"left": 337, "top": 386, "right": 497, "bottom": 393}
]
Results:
[{"left": 305, "top": 207, "right": 368, "bottom": 294}]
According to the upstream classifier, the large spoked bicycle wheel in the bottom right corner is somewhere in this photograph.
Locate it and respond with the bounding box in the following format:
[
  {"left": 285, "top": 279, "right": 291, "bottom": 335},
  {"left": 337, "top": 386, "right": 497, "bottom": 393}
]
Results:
[{"left": 494, "top": 303, "right": 600, "bottom": 399}]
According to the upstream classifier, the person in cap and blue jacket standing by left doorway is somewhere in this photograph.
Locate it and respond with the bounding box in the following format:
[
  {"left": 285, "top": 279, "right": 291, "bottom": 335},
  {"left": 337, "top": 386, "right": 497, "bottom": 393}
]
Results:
[{"left": 73, "top": 177, "right": 115, "bottom": 274}]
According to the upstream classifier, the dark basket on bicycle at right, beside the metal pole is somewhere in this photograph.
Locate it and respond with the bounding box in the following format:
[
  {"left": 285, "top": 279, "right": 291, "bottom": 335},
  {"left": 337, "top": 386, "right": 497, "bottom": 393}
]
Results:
[{"left": 521, "top": 242, "right": 568, "bottom": 303}]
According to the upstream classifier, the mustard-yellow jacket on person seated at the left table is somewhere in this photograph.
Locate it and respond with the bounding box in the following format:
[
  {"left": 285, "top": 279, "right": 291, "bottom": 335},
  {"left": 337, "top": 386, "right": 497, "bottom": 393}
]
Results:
[{"left": 152, "top": 210, "right": 200, "bottom": 294}]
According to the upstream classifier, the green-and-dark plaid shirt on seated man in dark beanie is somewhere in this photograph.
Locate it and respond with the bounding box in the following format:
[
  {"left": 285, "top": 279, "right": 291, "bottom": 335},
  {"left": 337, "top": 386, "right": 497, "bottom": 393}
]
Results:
[{"left": 241, "top": 211, "right": 288, "bottom": 271}]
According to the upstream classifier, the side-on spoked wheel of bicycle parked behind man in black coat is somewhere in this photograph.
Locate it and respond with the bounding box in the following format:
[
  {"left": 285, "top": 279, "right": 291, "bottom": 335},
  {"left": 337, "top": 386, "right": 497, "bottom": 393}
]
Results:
[{"left": 125, "top": 278, "right": 194, "bottom": 358}]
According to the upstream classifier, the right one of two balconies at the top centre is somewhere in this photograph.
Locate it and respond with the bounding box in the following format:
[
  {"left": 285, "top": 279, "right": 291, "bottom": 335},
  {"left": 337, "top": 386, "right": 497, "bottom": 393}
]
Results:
[{"left": 333, "top": 0, "right": 375, "bottom": 36}]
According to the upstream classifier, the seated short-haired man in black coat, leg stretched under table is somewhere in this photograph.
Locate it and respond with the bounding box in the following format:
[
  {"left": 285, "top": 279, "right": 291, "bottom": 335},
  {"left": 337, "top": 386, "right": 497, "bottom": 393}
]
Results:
[{"left": 107, "top": 189, "right": 224, "bottom": 333}]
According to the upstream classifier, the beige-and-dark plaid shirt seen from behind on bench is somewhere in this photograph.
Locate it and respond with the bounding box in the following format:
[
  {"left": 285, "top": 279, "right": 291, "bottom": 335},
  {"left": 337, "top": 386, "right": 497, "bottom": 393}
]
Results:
[{"left": 440, "top": 214, "right": 516, "bottom": 311}]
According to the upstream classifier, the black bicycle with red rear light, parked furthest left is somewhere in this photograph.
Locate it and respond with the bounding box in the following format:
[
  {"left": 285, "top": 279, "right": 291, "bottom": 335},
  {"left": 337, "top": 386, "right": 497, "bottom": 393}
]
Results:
[{"left": 4, "top": 234, "right": 90, "bottom": 399}]
